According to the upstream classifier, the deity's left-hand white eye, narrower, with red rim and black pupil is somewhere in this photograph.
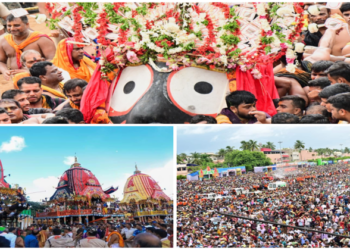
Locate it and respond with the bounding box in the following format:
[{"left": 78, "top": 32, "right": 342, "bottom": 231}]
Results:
[{"left": 109, "top": 65, "right": 153, "bottom": 116}]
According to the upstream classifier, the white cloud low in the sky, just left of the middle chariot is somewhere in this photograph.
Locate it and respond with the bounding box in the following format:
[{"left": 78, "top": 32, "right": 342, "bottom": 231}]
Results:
[{"left": 26, "top": 176, "right": 59, "bottom": 201}]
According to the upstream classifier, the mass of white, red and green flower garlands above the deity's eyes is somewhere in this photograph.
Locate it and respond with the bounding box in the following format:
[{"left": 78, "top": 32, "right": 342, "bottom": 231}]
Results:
[{"left": 43, "top": 2, "right": 303, "bottom": 79}]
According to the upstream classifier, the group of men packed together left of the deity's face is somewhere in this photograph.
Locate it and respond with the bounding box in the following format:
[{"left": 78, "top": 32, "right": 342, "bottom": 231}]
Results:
[{"left": 0, "top": 3, "right": 96, "bottom": 124}]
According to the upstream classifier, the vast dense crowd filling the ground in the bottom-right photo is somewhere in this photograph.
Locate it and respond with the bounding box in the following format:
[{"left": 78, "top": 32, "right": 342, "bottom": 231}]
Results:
[{"left": 177, "top": 164, "right": 350, "bottom": 248}]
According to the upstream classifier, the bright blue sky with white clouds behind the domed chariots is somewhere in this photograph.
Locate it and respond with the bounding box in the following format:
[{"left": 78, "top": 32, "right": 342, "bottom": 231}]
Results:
[{"left": 0, "top": 126, "right": 174, "bottom": 201}]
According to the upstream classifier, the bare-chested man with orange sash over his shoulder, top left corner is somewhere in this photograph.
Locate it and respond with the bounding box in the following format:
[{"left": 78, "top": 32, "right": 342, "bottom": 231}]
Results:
[{"left": 0, "top": 14, "right": 56, "bottom": 80}]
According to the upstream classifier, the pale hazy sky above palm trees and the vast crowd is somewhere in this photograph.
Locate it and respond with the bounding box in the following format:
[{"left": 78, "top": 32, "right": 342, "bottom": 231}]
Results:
[{"left": 177, "top": 125, "right": 350, "bottom": 154}]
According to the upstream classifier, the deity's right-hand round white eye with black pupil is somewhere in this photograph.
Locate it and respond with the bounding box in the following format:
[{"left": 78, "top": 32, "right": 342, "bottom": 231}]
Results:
[{"left": 167, "top": 67, "right": 228, "bottom": 116}]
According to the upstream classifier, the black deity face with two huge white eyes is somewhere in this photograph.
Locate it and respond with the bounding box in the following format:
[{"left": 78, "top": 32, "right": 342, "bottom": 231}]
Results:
[{"left": 107, "top": 62, "right": 229, "bottom": 123}]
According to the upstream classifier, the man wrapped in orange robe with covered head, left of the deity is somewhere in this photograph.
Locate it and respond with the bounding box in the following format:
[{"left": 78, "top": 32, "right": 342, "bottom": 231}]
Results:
[{"left": 52, "top": 38, "right": 96, "bottom": 82}]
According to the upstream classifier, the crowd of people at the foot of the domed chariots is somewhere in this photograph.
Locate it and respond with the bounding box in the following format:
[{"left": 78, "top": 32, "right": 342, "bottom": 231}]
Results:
[{"left": 0, "top": 219, "right": 173, "bottom": 248}]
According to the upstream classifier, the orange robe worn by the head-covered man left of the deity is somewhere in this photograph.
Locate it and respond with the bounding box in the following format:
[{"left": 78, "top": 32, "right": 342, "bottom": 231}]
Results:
[{"left": 52, "top": 39, "right": 96, "bottom": 82}]
